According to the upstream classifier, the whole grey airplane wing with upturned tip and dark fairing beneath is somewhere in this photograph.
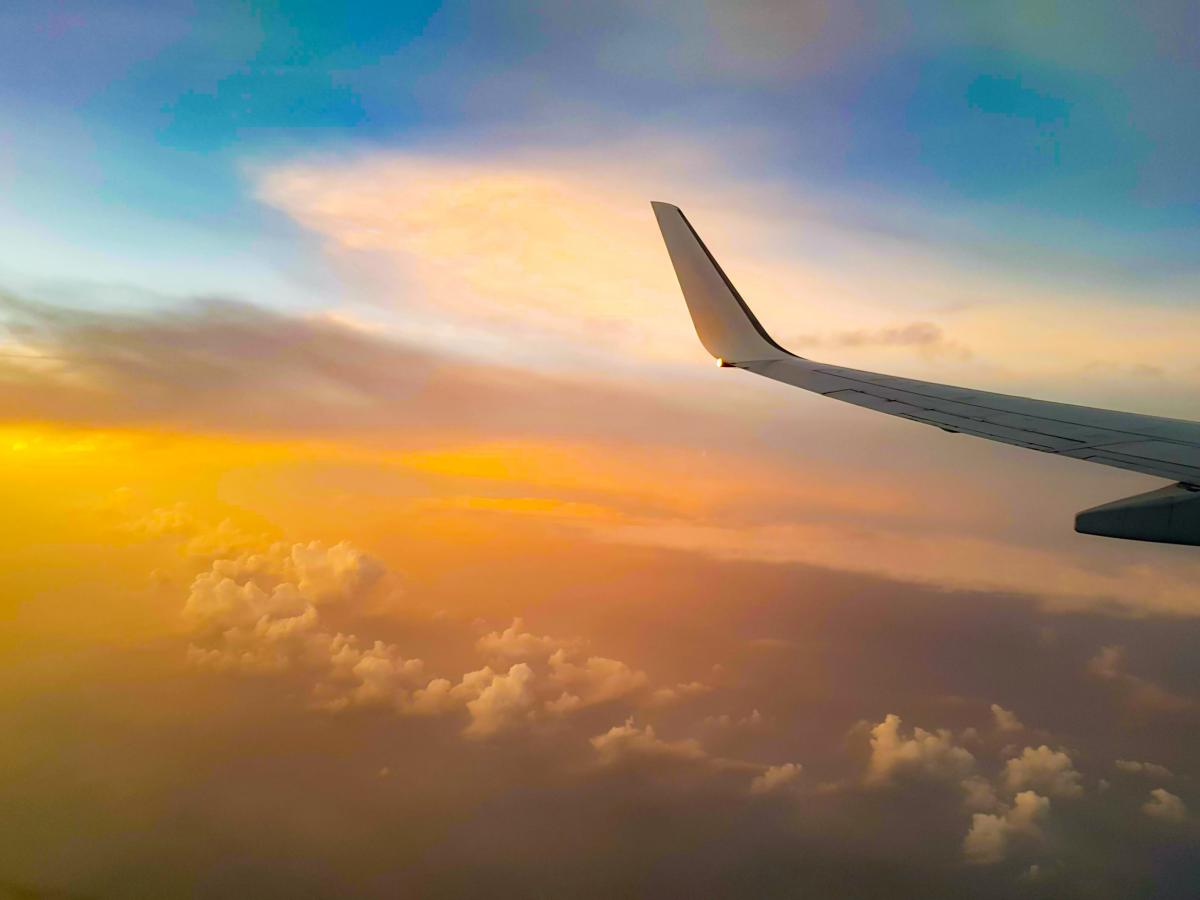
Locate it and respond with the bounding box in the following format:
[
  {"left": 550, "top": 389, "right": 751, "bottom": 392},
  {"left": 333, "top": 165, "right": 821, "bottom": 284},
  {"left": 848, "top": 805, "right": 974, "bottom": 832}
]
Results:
[{"left": 650, "top": 203, "right": 1200, "bottom": 546}]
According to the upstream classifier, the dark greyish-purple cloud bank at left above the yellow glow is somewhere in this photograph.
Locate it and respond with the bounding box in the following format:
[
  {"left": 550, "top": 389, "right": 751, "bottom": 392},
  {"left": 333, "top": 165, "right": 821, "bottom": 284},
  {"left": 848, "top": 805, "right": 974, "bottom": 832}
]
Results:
[{"left": 0, "top": 289, "right": 433, "bottom": 430}]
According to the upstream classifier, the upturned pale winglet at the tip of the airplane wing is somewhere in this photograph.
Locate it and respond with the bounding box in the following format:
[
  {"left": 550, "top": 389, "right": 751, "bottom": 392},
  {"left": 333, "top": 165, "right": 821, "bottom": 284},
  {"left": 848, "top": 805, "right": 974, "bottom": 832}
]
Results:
[{"left": 650, "top": 202, "right": 793, "bottom": 366}]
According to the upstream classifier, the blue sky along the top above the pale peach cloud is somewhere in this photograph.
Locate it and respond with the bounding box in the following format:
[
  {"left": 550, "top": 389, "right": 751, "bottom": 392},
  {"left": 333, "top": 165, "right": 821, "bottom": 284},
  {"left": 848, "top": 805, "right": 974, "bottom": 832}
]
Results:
[{"left": 7, "top": 2, "right": 1200, "bottom": 283}]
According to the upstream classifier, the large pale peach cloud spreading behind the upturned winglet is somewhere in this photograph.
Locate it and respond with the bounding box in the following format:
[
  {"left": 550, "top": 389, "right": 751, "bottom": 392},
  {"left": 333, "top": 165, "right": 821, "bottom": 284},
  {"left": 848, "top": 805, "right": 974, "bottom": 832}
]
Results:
[{"left": 250, "top": 148, "right": 1194, "bottom": 409}]
